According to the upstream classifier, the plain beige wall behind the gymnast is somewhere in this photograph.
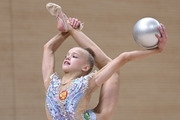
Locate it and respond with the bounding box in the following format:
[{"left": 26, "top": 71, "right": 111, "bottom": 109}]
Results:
[{"left": 0, "top": 0, "right": 180, "bottom": 120}]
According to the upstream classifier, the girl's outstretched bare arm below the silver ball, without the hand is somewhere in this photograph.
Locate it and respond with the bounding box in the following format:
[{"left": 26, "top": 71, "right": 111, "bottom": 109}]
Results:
[{"left": 94, "top": 49, "right": 160, "bottom": 86}]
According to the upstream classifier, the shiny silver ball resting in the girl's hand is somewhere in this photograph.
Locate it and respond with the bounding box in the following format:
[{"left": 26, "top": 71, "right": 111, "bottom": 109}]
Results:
[{"left": 133, "top": 17, "right": 160, "bottom": 49}]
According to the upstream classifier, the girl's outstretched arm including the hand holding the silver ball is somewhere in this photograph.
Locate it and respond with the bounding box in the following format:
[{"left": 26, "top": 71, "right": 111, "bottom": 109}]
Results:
[{"left": 90, "top": 24, "right": 168, "bottom": 88}]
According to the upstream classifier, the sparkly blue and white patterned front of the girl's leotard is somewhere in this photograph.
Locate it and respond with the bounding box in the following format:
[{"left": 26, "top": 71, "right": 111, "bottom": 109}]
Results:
[{"left": 46, "top": 73, "right": 92, "bottom": 120}]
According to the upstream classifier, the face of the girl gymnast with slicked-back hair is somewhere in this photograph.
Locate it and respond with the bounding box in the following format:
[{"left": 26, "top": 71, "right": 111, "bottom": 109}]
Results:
[{"left": 62, "top": 47, "right": 89, "bottom": 73}]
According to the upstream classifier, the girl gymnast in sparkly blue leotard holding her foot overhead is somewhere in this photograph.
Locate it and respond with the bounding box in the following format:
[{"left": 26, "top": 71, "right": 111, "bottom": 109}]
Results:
[{"left": 42, "top": 4, "right": 166, "bottom": 120}]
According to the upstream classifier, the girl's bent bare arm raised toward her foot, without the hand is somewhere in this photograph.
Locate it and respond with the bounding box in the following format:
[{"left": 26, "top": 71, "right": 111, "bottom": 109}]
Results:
[{"left": 42, "top": 33, "right": 69, "bottom": 89}]
